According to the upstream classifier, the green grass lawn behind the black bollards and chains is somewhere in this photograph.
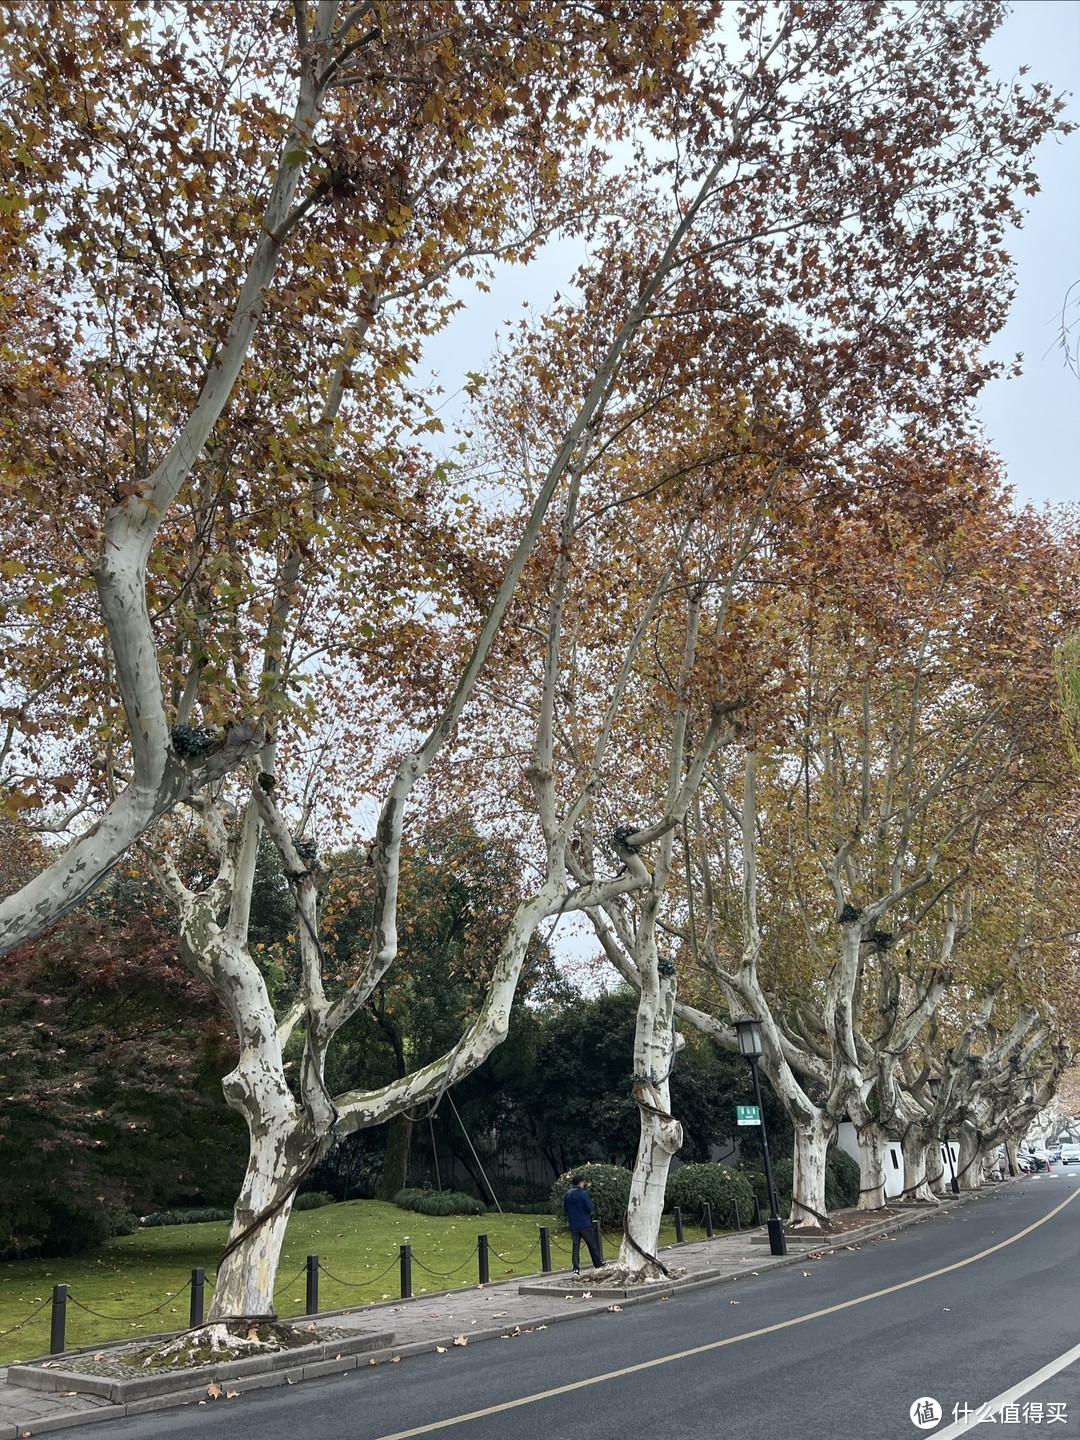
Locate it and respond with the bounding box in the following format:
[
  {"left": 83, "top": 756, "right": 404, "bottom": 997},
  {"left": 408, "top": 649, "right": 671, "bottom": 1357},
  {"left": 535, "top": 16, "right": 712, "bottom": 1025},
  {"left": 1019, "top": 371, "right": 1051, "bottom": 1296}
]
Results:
[{"left": 0, "top": 1200, "right": 704, "bottom": 1364}]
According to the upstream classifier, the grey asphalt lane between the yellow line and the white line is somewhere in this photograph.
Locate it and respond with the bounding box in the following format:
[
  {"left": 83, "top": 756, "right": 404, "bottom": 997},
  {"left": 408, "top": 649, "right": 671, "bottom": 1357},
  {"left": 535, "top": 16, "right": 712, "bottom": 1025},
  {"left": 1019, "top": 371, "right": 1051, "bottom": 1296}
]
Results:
[{"left": 426, "top": 1197, "right": 1080, "bottom": 1440}]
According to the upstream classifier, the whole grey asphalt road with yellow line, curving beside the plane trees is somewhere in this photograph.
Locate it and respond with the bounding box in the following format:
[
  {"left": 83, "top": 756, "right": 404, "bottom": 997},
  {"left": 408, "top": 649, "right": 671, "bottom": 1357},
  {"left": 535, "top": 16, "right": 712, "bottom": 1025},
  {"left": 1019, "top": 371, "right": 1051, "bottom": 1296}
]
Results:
[{"left": 61, "top": 1168, "right": 1080, "bottom": 1440}]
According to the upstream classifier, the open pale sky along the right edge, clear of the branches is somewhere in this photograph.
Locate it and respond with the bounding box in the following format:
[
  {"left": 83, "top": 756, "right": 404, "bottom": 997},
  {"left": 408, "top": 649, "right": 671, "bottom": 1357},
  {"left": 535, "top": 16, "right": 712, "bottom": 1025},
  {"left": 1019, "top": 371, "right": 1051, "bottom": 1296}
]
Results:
[{"left": 979, "top": 0, "right": 1080, "bottom": 503}]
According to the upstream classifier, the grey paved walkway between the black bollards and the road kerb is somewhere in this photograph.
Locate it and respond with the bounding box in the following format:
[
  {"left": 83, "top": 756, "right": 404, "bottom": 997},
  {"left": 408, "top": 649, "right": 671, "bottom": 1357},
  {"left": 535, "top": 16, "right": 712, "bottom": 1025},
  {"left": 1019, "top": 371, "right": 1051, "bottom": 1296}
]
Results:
[{"left": 0, "top": 1195, "right": 969, "bottom": 1440}]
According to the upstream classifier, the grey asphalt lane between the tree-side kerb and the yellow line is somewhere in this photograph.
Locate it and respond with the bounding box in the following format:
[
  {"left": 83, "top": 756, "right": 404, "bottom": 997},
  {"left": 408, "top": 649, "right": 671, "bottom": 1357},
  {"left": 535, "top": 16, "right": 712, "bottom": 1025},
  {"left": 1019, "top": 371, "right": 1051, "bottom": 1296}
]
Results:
[{"left": 59, "top": 1182, "right": 1080, "bottom": 1440}]
